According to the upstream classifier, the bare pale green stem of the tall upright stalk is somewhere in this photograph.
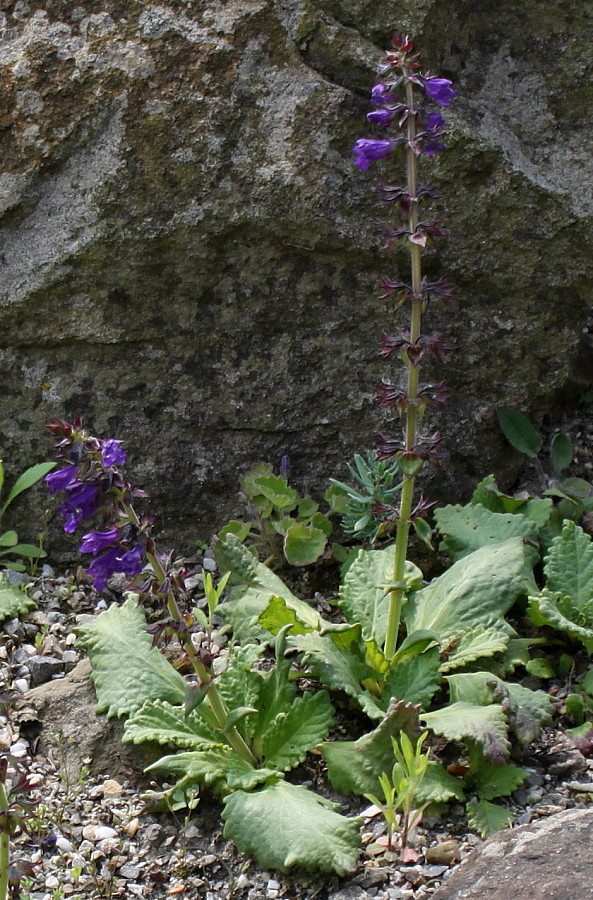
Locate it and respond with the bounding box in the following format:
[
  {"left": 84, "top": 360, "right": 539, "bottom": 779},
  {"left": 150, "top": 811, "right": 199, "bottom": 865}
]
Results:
[{"left": 384, "top": 75, "right": 422, "bottom": 659}]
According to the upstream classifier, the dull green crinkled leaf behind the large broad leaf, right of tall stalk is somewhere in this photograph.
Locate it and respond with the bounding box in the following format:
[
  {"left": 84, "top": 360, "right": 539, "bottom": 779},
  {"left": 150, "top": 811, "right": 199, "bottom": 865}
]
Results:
[{"left": 434, "top": 504, "right": 538, "bottom": 560}]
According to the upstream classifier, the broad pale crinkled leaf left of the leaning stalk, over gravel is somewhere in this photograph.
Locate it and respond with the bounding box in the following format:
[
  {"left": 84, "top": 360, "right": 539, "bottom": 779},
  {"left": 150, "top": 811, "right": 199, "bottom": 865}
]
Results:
[{"left": 79, "top": 595, "right": 185, "bottom": 716}]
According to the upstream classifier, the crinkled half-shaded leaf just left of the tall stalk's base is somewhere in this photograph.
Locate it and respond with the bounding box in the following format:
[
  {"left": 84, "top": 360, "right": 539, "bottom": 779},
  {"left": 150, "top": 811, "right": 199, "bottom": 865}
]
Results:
[{"left": 290, "top": 625, "right": 376, "bottom": 697}]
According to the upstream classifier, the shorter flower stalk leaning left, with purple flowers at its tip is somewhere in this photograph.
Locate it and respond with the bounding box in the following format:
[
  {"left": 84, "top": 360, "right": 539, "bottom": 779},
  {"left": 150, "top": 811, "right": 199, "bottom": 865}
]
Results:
[{"left": 42, "top": 419, "right": 255, "bottom": 764}]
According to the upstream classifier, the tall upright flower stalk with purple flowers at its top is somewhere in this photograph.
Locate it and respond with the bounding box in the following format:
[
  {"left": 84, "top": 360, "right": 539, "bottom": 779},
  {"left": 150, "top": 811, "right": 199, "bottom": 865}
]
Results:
[{"left": 354, "top": 34, "right": 455, "bottom": 659}]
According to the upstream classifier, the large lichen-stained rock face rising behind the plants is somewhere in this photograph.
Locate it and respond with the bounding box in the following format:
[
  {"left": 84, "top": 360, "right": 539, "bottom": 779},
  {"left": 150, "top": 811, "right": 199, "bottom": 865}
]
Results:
[{"left": 0, "top": 0, "right": 593, "bottom": 544}]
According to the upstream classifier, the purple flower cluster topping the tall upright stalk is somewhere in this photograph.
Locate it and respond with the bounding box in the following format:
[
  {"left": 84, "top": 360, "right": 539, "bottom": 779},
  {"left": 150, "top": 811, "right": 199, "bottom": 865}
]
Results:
[{"left": 353, "top": 35, "right": 455, "bottom": 172}]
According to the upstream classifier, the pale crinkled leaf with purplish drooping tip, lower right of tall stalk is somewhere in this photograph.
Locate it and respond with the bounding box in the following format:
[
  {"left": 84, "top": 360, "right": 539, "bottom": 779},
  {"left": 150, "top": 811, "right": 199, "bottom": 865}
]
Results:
[{"left": 420, "top": 701, "right": 511, "bottom": 764}]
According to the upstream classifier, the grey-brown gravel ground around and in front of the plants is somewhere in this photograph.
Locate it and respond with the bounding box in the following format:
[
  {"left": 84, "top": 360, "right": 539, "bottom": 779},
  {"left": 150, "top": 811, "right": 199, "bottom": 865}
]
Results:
[{"left": 0, "top": 566, "right": 593, "bottom": 900}]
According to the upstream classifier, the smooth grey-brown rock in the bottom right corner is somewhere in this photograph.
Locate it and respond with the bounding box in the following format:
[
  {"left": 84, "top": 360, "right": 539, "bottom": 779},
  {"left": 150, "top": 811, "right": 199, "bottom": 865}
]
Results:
[{"left": 432, "top": 809, "right": 593, "bottom": 900}]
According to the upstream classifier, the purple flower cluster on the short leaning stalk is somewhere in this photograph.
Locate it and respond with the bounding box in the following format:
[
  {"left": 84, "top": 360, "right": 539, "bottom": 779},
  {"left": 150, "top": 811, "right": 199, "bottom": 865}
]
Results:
[{"left": 45, "top": 419, "right": 152, "bottom": 591}]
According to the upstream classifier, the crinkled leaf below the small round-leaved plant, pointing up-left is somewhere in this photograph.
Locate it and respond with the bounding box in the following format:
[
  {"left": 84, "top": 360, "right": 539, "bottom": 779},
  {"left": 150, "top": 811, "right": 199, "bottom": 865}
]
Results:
[{"left": 215, "top": 534, "right": 321, "bottom": 643}]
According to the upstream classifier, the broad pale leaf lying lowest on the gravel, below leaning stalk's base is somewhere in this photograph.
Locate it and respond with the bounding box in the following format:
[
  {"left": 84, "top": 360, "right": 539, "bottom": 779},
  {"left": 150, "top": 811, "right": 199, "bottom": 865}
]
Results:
[{"left": 222, "top": 781, "right": 362, "bottom": 875}]
